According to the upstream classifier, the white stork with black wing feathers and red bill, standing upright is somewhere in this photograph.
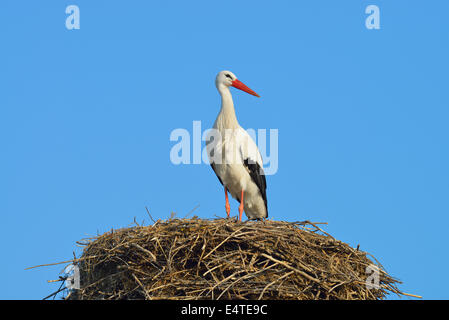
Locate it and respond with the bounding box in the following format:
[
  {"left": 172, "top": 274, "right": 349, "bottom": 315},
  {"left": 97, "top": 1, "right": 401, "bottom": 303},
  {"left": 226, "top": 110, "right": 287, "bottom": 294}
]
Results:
[{"left": 206, "top": 71, "right": 268, "bottom": 221}]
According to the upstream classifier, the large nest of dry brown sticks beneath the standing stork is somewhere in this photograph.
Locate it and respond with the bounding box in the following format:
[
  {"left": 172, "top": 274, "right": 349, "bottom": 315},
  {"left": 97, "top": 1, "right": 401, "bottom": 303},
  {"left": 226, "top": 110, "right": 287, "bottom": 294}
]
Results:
[{"left": 68, "top": 217, "right": 402, "bottom": 300}]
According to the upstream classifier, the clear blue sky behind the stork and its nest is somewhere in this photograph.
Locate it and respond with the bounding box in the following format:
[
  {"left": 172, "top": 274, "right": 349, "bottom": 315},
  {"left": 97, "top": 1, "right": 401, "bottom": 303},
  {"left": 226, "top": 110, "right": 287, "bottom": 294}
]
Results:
[{"left": 0, "top": 0, "right": 449, "bottom": 299}]
